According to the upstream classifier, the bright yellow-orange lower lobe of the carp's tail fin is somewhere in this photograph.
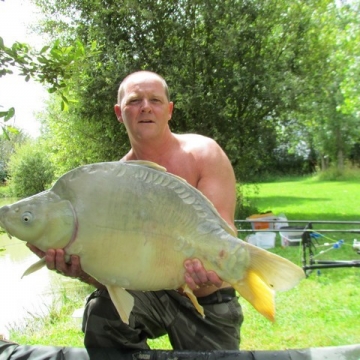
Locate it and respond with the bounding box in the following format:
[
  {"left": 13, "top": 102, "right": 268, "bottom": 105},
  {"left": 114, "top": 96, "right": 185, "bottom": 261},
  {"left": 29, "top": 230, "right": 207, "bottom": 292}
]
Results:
[{"left": 231, "top": 269, "right": 275, "bottom": 322}]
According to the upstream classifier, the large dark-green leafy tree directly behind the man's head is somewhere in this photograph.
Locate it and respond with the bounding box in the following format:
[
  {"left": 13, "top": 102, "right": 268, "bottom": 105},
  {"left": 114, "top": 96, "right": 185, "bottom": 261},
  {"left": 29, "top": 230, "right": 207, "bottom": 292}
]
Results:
[{"left": 36, "top": 0, "right": 358, "bottom": 181}]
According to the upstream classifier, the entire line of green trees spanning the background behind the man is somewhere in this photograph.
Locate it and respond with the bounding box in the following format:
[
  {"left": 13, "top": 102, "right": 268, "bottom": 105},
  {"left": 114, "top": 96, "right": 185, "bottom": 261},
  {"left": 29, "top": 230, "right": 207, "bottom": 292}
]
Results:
[{"left": 0, "top": 0, "right": 360, "bottom": 194}]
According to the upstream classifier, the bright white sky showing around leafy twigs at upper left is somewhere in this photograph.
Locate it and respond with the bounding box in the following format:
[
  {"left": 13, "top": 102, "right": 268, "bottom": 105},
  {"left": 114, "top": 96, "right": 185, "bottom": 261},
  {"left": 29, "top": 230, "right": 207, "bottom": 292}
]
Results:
[{"left": 0, "top": 0, "right": 47, "bottom": 138}]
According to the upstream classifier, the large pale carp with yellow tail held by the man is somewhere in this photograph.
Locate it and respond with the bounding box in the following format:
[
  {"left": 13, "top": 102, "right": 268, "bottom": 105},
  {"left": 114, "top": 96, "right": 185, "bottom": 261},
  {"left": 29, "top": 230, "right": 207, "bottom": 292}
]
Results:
[{"left": 0, "top": 161, "right": 304, "bottom": 322}]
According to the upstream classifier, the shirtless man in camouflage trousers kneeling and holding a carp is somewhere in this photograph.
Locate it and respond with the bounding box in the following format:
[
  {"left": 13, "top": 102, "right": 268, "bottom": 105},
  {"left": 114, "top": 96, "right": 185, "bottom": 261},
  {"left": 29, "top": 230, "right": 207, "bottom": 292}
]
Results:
[{"left": 29, "top": 71, "right": 243, "bottom": 350}]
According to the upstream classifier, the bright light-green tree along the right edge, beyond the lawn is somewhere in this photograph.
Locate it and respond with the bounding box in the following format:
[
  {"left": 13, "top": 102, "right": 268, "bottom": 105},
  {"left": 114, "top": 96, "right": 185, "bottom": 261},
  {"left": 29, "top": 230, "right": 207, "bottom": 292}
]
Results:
[{"left": 280, "top": 2, "right": 360, "bottom": 170}]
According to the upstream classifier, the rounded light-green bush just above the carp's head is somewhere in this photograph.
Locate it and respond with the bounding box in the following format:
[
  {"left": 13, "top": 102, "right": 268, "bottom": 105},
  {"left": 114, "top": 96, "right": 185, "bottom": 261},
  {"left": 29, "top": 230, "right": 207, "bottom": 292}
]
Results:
[{"left": 8, "top": 142, "right": 54, "bottom": 197}]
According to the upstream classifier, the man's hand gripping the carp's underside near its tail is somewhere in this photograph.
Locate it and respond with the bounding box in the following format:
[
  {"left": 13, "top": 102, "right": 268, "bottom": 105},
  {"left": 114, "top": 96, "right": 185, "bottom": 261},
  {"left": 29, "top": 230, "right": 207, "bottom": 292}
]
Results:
[{"left": 184, "top": 259, "right": 223, "bottom": 290}]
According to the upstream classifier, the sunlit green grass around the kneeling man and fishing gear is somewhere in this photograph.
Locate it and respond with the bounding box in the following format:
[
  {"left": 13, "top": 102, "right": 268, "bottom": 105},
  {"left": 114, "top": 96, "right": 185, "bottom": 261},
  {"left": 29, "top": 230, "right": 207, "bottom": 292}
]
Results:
[{"left": 6, "top": 177, "right": 360, "bottom": 350}]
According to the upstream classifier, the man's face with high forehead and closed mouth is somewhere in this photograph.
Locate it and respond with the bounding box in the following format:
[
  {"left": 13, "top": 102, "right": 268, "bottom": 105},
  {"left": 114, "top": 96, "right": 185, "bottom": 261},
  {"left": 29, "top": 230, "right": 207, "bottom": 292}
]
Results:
[{"left": 115, "top": 75, "right": 173, "bottom": 140}]
